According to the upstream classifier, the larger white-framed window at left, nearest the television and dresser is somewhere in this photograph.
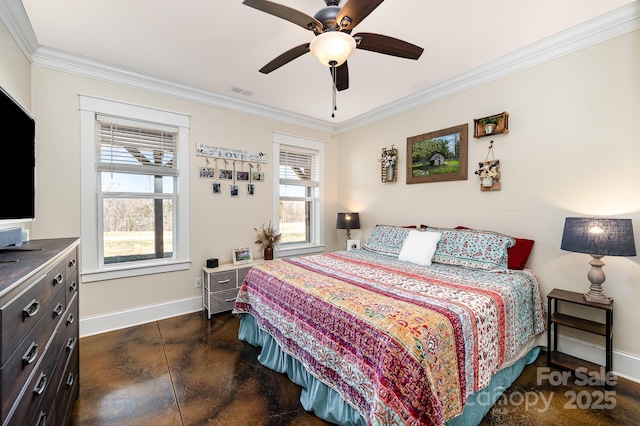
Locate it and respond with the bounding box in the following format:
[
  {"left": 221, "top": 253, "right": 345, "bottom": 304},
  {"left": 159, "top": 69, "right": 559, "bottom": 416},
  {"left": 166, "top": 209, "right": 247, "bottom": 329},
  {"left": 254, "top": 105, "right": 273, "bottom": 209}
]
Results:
[{"left": 81, "top": 96, "right": 189, "bottom": 281}]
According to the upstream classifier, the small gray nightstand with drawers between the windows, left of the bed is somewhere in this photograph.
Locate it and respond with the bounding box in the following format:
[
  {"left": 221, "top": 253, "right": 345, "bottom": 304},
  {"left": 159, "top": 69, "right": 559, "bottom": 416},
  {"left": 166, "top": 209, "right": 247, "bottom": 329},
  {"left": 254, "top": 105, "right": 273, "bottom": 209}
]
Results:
[{"left": 202, "top": 259, "right": 263, "bottom": 319}]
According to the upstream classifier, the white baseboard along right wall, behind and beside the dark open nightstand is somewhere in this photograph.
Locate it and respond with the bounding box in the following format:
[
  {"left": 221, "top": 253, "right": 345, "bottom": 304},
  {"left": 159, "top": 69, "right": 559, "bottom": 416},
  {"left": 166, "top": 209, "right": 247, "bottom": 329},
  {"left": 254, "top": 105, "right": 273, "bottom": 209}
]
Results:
[{"left": 558, "top": 334, "right": 640, "bottom": 383}]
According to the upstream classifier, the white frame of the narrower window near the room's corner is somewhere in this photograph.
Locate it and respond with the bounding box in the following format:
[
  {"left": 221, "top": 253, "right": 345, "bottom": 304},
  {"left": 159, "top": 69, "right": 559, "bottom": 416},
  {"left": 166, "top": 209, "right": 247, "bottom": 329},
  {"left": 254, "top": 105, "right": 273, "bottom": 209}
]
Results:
[{"left": 272, "top": 133, "right": 325, "bottom": 256}]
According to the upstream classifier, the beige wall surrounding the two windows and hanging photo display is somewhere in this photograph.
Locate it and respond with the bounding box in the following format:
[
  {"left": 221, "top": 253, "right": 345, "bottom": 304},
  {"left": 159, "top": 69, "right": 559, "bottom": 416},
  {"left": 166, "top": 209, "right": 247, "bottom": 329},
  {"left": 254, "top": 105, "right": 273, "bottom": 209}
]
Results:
[{"left": 32, "top": 67, "right": 337, "bottom": 318}]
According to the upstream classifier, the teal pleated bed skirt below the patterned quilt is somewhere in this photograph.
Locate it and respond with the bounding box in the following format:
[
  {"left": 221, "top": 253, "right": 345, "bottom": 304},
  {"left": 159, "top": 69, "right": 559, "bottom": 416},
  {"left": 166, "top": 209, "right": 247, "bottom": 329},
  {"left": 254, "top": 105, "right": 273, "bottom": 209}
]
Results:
[{"left": 238, "top": 314, "right": 540, "bottom": 426}]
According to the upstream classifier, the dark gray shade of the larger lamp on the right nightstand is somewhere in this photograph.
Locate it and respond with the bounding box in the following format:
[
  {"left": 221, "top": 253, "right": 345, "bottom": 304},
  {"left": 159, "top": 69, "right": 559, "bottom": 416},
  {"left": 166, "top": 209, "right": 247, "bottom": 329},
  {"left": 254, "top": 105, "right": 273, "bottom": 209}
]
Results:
[{"left": 560, "top": 217, "right": 636, "bottom": 256}]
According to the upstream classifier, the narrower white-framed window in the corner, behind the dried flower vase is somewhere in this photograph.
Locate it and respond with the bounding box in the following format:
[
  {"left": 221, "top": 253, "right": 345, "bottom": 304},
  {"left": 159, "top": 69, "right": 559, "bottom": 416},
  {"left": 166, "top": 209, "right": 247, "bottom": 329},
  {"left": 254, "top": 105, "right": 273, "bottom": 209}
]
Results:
[{"left": 274, "top": 134, "right": 324, "bottom": 254}]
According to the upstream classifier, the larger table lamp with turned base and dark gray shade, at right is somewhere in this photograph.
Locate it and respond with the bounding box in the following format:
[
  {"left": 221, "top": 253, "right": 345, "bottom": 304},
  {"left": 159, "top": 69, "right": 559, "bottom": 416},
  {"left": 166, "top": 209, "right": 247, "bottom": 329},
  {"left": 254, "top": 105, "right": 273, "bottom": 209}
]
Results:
[{"left": 560, "top": 217, "right": 636, "bottom": 305}]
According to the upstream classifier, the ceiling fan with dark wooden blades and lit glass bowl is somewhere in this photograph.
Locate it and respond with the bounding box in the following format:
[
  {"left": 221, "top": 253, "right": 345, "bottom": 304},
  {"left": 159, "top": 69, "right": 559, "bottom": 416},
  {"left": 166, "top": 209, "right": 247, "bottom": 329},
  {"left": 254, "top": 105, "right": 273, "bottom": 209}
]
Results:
[{"left": 242, "top": 0, "right": 424, "bottom": 93}]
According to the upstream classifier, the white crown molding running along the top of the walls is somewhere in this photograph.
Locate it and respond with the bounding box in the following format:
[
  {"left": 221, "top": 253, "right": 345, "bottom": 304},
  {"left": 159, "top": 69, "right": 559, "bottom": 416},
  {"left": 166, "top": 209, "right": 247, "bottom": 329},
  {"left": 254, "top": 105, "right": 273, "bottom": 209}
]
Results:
[{"left": 0, "top": 0, "right": 640, "bottom": 134}]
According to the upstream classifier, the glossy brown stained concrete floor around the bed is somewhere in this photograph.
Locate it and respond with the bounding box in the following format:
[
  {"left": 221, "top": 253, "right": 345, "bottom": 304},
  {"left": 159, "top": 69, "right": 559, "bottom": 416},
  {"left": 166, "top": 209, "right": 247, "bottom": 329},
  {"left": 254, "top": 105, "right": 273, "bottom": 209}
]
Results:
[{"left": 71, "top": 312, "right": 640, "bottom": 426}]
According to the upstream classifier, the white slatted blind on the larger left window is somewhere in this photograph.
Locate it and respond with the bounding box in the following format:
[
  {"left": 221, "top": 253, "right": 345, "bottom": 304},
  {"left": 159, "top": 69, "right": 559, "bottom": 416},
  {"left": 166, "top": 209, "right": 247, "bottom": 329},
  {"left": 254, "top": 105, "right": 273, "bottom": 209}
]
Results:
[{"left": 96, "top": 117, "right": 178, "bottom": 176}]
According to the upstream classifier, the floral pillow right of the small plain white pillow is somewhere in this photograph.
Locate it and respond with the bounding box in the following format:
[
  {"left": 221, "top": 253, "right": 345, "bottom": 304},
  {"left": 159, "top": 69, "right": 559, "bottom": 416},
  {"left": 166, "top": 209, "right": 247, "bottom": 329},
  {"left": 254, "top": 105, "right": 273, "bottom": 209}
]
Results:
[{"left": 425, "top": 228, "right": 516, "bottom": 270}]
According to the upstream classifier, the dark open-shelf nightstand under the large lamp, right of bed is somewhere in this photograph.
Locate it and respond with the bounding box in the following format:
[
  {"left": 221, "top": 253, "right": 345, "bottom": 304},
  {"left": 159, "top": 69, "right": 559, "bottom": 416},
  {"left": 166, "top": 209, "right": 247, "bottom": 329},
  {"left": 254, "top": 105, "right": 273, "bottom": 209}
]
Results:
[{"left": 547, "top": 288, "right": 613, "bottom": 384}]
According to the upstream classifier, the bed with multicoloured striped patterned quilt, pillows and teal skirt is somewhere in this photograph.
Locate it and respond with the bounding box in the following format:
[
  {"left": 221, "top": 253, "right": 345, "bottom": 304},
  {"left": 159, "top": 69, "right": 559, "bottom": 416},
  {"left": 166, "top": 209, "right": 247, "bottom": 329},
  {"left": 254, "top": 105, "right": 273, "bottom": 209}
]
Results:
[{"left": 233, "top": 225, "right": 545, "bottom": 426}]
